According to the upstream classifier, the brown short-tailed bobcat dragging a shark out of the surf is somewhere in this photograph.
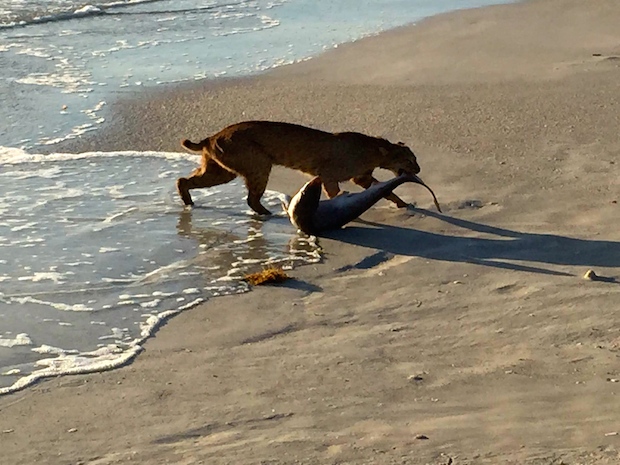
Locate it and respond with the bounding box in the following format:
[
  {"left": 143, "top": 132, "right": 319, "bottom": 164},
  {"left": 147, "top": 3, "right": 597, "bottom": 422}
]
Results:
[{"left": 177, "top": 121, "right": 420, "bottom": 215}]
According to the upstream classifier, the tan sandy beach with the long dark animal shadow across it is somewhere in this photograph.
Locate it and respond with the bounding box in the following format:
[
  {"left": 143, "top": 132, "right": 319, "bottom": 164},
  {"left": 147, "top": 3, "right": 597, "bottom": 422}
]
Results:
[{"left": 0, "top": 0, "right": 620, "bottom": 465}]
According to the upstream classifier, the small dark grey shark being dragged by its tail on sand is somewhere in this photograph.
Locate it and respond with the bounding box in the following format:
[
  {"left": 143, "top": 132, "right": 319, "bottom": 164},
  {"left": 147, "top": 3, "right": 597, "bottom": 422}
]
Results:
[{"left": 284, "top": 174, "right": 441, "bottom": 236}]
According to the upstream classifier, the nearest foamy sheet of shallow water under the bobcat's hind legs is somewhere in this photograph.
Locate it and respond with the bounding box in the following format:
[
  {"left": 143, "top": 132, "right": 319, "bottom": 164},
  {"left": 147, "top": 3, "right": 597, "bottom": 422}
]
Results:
[{"left": 0, "top": 151, "right": 320, "bottom": 389}]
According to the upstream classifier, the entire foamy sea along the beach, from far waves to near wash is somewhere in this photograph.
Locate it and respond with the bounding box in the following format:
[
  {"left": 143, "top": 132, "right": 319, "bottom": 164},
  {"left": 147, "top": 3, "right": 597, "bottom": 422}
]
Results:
[{"left": 0, "top": 0, "right": 506, "bottom": 394}]
